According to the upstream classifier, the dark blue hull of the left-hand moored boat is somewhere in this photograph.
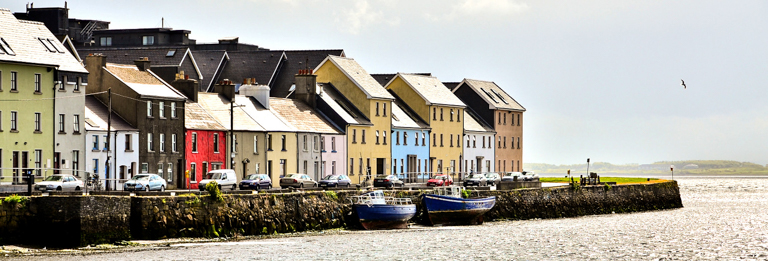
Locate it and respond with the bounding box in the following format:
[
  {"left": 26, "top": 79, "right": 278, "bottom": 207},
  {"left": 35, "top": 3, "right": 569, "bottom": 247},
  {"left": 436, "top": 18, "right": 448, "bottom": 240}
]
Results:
[{"left": 354, "top": 204, "right": 416, "bottom": 230}]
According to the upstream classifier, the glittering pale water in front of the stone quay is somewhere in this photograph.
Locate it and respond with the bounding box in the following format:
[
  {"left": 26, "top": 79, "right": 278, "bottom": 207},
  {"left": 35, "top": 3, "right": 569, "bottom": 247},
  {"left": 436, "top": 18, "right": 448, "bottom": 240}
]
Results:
[{"left": 19, "top": 178, "right": 768, "bottom": 260}]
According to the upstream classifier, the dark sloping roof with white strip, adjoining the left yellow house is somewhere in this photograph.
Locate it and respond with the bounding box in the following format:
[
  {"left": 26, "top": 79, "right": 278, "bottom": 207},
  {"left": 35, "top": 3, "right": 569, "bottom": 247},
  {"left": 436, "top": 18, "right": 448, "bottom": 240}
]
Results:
[{"left": 318, "top": 83, "right": 372, "bottom": 125}]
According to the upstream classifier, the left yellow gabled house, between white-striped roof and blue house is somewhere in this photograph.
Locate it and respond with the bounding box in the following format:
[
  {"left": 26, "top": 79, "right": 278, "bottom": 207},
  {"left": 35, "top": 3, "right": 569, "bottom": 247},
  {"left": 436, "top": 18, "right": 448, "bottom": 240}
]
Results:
[{"left": 315, "top": 55, "right": 395, "bottom": 182}]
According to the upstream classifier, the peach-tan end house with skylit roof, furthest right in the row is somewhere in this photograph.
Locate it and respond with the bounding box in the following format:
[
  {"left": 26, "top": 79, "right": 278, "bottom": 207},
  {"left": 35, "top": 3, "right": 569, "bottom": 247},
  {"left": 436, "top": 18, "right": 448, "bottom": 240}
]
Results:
[{"left": 453, "top": 79, "right": 526, "bottom": 172}]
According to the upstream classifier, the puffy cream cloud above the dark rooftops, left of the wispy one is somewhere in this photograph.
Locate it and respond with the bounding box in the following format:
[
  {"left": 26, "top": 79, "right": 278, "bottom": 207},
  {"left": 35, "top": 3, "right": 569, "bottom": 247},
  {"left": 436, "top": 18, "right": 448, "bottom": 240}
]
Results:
[{"left": 336, "top": 1, "right": 400, "bottom": 34}]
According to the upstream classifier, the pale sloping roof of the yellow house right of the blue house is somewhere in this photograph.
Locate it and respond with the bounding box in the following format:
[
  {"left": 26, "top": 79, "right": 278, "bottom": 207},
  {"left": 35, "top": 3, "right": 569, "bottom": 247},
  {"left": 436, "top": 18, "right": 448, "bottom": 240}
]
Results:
[{"left": 387, "top": 73, "right": 466, "bottom": 108}]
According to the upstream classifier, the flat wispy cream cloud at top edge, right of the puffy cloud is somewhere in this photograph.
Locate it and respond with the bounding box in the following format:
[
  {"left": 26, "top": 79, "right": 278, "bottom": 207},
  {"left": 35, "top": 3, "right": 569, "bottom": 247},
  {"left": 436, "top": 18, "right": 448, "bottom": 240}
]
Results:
[{"left": 425, "top": 0, "right": 529, "bottom": 21}]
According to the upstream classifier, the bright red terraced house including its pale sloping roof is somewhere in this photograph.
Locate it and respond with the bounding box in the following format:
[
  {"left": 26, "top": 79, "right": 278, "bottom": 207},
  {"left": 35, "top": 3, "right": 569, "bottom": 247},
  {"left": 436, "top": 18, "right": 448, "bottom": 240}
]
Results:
[{"left": 184, "top": 102, "right": 227, "bottom": 189}]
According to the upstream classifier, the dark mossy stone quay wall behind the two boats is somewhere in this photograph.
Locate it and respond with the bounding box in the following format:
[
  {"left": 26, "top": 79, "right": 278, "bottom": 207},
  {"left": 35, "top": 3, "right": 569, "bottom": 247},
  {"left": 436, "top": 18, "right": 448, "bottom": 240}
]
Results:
[{"left": 0, "top": 181, "right": 683, "bottom": 247}]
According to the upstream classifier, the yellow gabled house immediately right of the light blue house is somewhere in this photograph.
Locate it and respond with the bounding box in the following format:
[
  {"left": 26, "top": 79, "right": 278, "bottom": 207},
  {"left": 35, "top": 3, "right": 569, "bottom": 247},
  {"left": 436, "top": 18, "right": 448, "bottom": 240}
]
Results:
[{"left": 386, "top": 73, "right": 466, "bottom": 174}]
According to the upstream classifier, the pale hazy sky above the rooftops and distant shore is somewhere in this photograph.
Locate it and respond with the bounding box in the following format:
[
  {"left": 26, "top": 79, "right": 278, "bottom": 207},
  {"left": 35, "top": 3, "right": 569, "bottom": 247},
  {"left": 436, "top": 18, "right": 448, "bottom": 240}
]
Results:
[{"left": 0, "top": 0, "right": 768, "bottom": 164}]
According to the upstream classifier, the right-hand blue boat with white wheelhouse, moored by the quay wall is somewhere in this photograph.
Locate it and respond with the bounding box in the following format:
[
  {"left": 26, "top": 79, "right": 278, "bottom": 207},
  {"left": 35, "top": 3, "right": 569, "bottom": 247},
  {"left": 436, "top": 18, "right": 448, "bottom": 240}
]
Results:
[{"left": 422, "top": 186, "right": 496, "bottom": 225}]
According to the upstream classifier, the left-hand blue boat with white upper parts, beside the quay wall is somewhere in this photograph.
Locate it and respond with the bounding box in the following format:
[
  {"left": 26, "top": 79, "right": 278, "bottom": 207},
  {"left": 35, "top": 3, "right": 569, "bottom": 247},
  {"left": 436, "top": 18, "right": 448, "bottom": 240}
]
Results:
[{"left": 349, "top": 190, "right": 416, "bottom": 230}]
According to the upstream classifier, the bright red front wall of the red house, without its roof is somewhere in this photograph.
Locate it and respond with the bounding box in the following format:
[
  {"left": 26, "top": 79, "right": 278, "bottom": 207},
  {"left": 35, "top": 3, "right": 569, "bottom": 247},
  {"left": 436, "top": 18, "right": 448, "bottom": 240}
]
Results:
[{"left": 184, "top": 129, "right": 226, "bottom": 189}]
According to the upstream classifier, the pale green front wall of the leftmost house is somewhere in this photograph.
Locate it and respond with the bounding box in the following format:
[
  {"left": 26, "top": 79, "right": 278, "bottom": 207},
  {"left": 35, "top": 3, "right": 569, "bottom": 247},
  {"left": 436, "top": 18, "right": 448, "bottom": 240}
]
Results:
[{"left": 0, "top": 63, "right": 54, "bottom": 184}]
